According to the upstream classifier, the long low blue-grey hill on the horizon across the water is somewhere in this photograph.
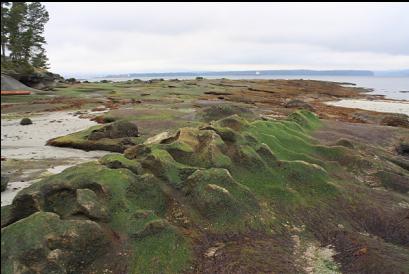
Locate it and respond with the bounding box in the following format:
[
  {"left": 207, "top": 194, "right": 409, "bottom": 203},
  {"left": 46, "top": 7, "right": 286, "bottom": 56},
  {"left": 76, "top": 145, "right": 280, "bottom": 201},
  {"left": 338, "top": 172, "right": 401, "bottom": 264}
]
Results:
[{"left": 104, "top": 69, "right": 375, "bottom": 78}]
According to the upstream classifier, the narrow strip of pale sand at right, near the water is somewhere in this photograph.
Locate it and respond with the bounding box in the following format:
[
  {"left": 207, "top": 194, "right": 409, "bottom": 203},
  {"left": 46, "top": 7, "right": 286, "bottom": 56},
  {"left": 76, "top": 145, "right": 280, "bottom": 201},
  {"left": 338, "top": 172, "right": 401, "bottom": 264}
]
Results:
[{"left": 326, "top": 99, "right": 409, "bottom": 115}]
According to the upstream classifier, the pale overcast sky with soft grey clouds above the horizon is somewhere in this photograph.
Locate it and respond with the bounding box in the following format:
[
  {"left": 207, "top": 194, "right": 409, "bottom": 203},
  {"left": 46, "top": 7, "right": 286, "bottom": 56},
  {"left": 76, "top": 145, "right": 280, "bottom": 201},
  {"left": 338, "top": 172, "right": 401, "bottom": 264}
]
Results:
[{"left": 44, "top": 2, "right": 409, "bottom": 75}]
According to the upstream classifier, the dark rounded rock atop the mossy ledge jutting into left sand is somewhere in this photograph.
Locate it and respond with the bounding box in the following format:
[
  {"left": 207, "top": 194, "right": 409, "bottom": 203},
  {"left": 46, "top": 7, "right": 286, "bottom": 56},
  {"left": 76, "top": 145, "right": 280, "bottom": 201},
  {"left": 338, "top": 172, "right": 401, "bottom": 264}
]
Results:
[{"left": 88, "top": 121, "right": 139, "bottom": 140}]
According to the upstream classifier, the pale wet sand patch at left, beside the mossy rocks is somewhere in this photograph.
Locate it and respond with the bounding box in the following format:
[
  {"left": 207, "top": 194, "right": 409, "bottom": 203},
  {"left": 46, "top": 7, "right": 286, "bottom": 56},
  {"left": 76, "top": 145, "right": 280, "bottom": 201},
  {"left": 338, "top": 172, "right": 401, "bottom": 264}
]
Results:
[{"left": 1, "top": 111, "right": 108, "bottom": 206}]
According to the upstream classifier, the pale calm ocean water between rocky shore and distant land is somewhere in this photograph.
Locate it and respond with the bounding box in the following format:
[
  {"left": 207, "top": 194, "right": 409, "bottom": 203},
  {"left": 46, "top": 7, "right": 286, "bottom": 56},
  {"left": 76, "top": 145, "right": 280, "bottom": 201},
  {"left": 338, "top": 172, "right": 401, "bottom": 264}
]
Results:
[{"left": 88, "top": 75, "right": 409, "bottom": 101}]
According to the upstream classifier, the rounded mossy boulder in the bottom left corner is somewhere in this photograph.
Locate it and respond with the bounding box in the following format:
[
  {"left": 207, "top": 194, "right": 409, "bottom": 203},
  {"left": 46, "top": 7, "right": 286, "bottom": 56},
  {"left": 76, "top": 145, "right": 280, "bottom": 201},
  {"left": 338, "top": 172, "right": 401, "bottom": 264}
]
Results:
[{"left": 1, "top": 212, "right": 110, "bottom": 274}]
